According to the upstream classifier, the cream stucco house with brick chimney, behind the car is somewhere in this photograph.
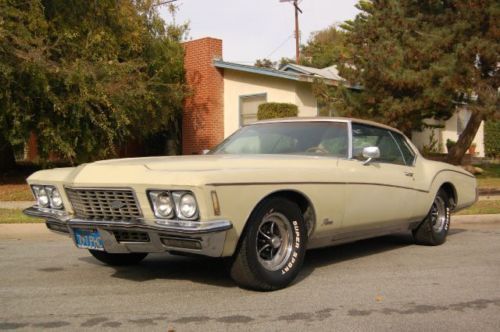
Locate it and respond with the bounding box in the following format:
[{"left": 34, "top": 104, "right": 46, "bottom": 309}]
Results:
[{"left": 183, "top": 38, "right": 484, "bottom": 157}]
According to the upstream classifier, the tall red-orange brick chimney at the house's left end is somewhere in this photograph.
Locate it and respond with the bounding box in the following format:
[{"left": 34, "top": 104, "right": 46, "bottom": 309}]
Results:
[{"left": 182, "top": 38, "right": 224, "bottom": 154}]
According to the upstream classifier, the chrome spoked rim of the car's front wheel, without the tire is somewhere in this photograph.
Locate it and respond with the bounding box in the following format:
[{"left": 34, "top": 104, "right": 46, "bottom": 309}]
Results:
[{"left": 256, "top": 212, "right": 293, "bottom": 271}]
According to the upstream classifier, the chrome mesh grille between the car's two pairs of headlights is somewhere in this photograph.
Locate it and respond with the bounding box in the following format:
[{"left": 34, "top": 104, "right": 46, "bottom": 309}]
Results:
[{"left": 66, "top": 188, "right": 141, "bottom": 222}]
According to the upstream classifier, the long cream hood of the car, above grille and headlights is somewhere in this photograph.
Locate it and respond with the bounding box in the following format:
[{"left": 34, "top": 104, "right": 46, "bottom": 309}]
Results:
[{"left": 28, "top": 155, "right": 338, "bottom": 187}]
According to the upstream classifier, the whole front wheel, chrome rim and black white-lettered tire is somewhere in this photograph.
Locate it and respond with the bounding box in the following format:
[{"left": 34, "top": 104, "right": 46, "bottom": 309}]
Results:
[{"left": 231, "top": 197, "right": 307, "bottom": 291}]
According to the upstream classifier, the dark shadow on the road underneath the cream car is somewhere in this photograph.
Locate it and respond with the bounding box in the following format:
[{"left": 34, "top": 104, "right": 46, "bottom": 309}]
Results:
[{"left": 80, "top": 228, "right": 465, "bottom": 287}]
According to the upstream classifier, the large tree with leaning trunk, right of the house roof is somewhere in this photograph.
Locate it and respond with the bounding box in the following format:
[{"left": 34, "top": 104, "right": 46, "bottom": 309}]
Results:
[{"left": 330, "top": 0, "right": 500, "bottom": 164}]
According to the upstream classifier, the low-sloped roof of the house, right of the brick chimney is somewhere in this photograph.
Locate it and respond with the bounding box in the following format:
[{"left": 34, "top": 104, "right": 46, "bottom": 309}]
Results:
[{"left": 214, "top": 60, "right": 343, "bottom": 85}]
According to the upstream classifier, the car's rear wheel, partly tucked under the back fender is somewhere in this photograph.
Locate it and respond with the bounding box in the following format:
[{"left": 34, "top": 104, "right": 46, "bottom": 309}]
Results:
[{"left": 413, "top": 189, "right": 450, "bottom": 246}]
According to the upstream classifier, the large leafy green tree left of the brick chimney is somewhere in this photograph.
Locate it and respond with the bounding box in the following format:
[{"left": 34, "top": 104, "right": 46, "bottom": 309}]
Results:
[{"left": 0, "top": 0, "right": 185, "bottom": 170}]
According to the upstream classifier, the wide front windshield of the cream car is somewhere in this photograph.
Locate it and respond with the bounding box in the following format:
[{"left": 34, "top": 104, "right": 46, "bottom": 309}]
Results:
[{"left": 210, "top": 122, "right": 348, "bottom": 158}]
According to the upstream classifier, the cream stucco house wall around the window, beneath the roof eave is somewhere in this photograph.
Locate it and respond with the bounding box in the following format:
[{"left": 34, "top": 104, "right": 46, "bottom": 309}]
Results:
[{"left": 224, "top": 69, "right": 318, "bottom": 137}]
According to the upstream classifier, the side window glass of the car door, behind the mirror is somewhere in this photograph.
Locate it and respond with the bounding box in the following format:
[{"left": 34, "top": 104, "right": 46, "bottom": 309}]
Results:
[{"left": 352, "top": 123, "right": 405, "bottom": 165}]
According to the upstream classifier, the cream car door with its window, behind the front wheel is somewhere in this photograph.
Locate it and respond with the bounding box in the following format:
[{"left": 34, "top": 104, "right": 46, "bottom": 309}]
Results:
[{"left": 339, "top": 123, "right": 415, "bottom": 229}]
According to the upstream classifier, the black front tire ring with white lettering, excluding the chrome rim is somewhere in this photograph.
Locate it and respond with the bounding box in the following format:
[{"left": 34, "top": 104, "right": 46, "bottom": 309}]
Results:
[{"left": 246, "top": 198, "right": 307, "bottom": 288}]
